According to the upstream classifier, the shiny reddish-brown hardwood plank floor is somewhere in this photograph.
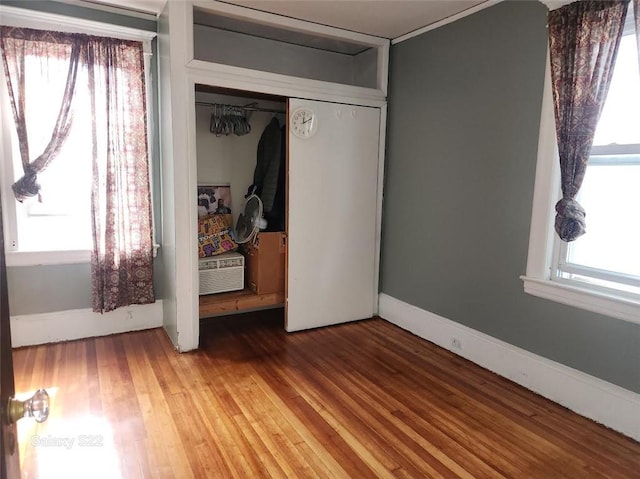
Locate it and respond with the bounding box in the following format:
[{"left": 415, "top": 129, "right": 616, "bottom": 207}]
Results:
[{"left": 14, "top": 310, "right": 640, "bottom": 479}]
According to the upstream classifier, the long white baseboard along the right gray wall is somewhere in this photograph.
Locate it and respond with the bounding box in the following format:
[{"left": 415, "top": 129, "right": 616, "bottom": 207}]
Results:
[{"left": 378, "top": 294, "right": 640, "bottom": 441}]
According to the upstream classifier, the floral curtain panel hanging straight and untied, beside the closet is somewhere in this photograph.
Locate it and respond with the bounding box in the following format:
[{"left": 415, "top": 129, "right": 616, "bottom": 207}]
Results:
[{"left": 86, "top": 37, "right": 155, "bottom": 312}]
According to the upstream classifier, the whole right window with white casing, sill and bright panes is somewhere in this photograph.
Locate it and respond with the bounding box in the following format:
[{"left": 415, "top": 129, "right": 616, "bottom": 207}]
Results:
[{"left": 522, "top": 8, "right": 640, "bottom": 323}]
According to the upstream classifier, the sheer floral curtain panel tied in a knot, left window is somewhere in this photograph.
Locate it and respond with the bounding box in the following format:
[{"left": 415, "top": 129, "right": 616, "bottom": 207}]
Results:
[{"left": 0, "top": 26, "right": 81, "bottom": 201}]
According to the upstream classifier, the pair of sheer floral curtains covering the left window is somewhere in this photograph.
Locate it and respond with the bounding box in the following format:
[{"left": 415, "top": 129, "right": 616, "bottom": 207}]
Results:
[{"left": 0, "top": 27, "right": 155, "bottom": 312}]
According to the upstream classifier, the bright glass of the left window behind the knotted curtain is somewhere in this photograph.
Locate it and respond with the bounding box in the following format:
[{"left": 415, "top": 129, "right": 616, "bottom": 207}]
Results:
[{"left": 1, "top": 56, "right": 92, "bottom": 252}]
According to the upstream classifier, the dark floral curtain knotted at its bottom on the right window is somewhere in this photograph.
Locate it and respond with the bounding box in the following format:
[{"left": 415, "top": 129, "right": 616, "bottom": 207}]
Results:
[{"left": 549, "top": 0, "right": 629, "bottom": 242}]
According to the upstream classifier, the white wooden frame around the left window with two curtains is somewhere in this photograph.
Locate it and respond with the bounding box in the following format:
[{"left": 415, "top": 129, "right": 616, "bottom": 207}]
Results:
[{"left": 0, "top": 5, "right": 159, "bottom": 267}]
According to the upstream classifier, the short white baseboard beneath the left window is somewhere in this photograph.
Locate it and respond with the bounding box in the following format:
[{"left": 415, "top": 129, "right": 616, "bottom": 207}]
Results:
[{"left": 11, "top": 300, "right": 162, "bottom": 348}]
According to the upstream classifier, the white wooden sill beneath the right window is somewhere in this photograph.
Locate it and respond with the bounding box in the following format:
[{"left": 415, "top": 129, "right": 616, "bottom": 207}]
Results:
[{"left": 520, "top": 276, "right": 640, "bottom": 324}]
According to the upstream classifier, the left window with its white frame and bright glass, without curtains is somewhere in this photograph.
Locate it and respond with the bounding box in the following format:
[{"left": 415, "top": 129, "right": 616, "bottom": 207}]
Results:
[{"left": 0, "top": 6, "right": 155, "bottom": 266}]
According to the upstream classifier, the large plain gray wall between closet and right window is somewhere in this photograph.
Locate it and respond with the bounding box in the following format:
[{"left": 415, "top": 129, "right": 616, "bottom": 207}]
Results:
[{"left": 381, "top": 2, "right": 640, "bottom": 392}]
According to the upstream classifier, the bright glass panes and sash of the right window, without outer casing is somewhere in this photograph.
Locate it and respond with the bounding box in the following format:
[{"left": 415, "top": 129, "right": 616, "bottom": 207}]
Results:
[{"left": 552, "top": 30, "right": 640, "bottom": 297}]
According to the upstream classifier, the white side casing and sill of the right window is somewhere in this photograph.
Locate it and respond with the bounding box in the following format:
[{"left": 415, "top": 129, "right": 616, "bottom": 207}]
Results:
[{"left": 520, "top": 48, "right": 640, "bottom": 324}]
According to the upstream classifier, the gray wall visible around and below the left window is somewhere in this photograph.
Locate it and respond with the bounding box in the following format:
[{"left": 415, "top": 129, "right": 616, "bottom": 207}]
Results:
[{"left": 0, "top": 0, "right": 162, "bottom": 315}]
